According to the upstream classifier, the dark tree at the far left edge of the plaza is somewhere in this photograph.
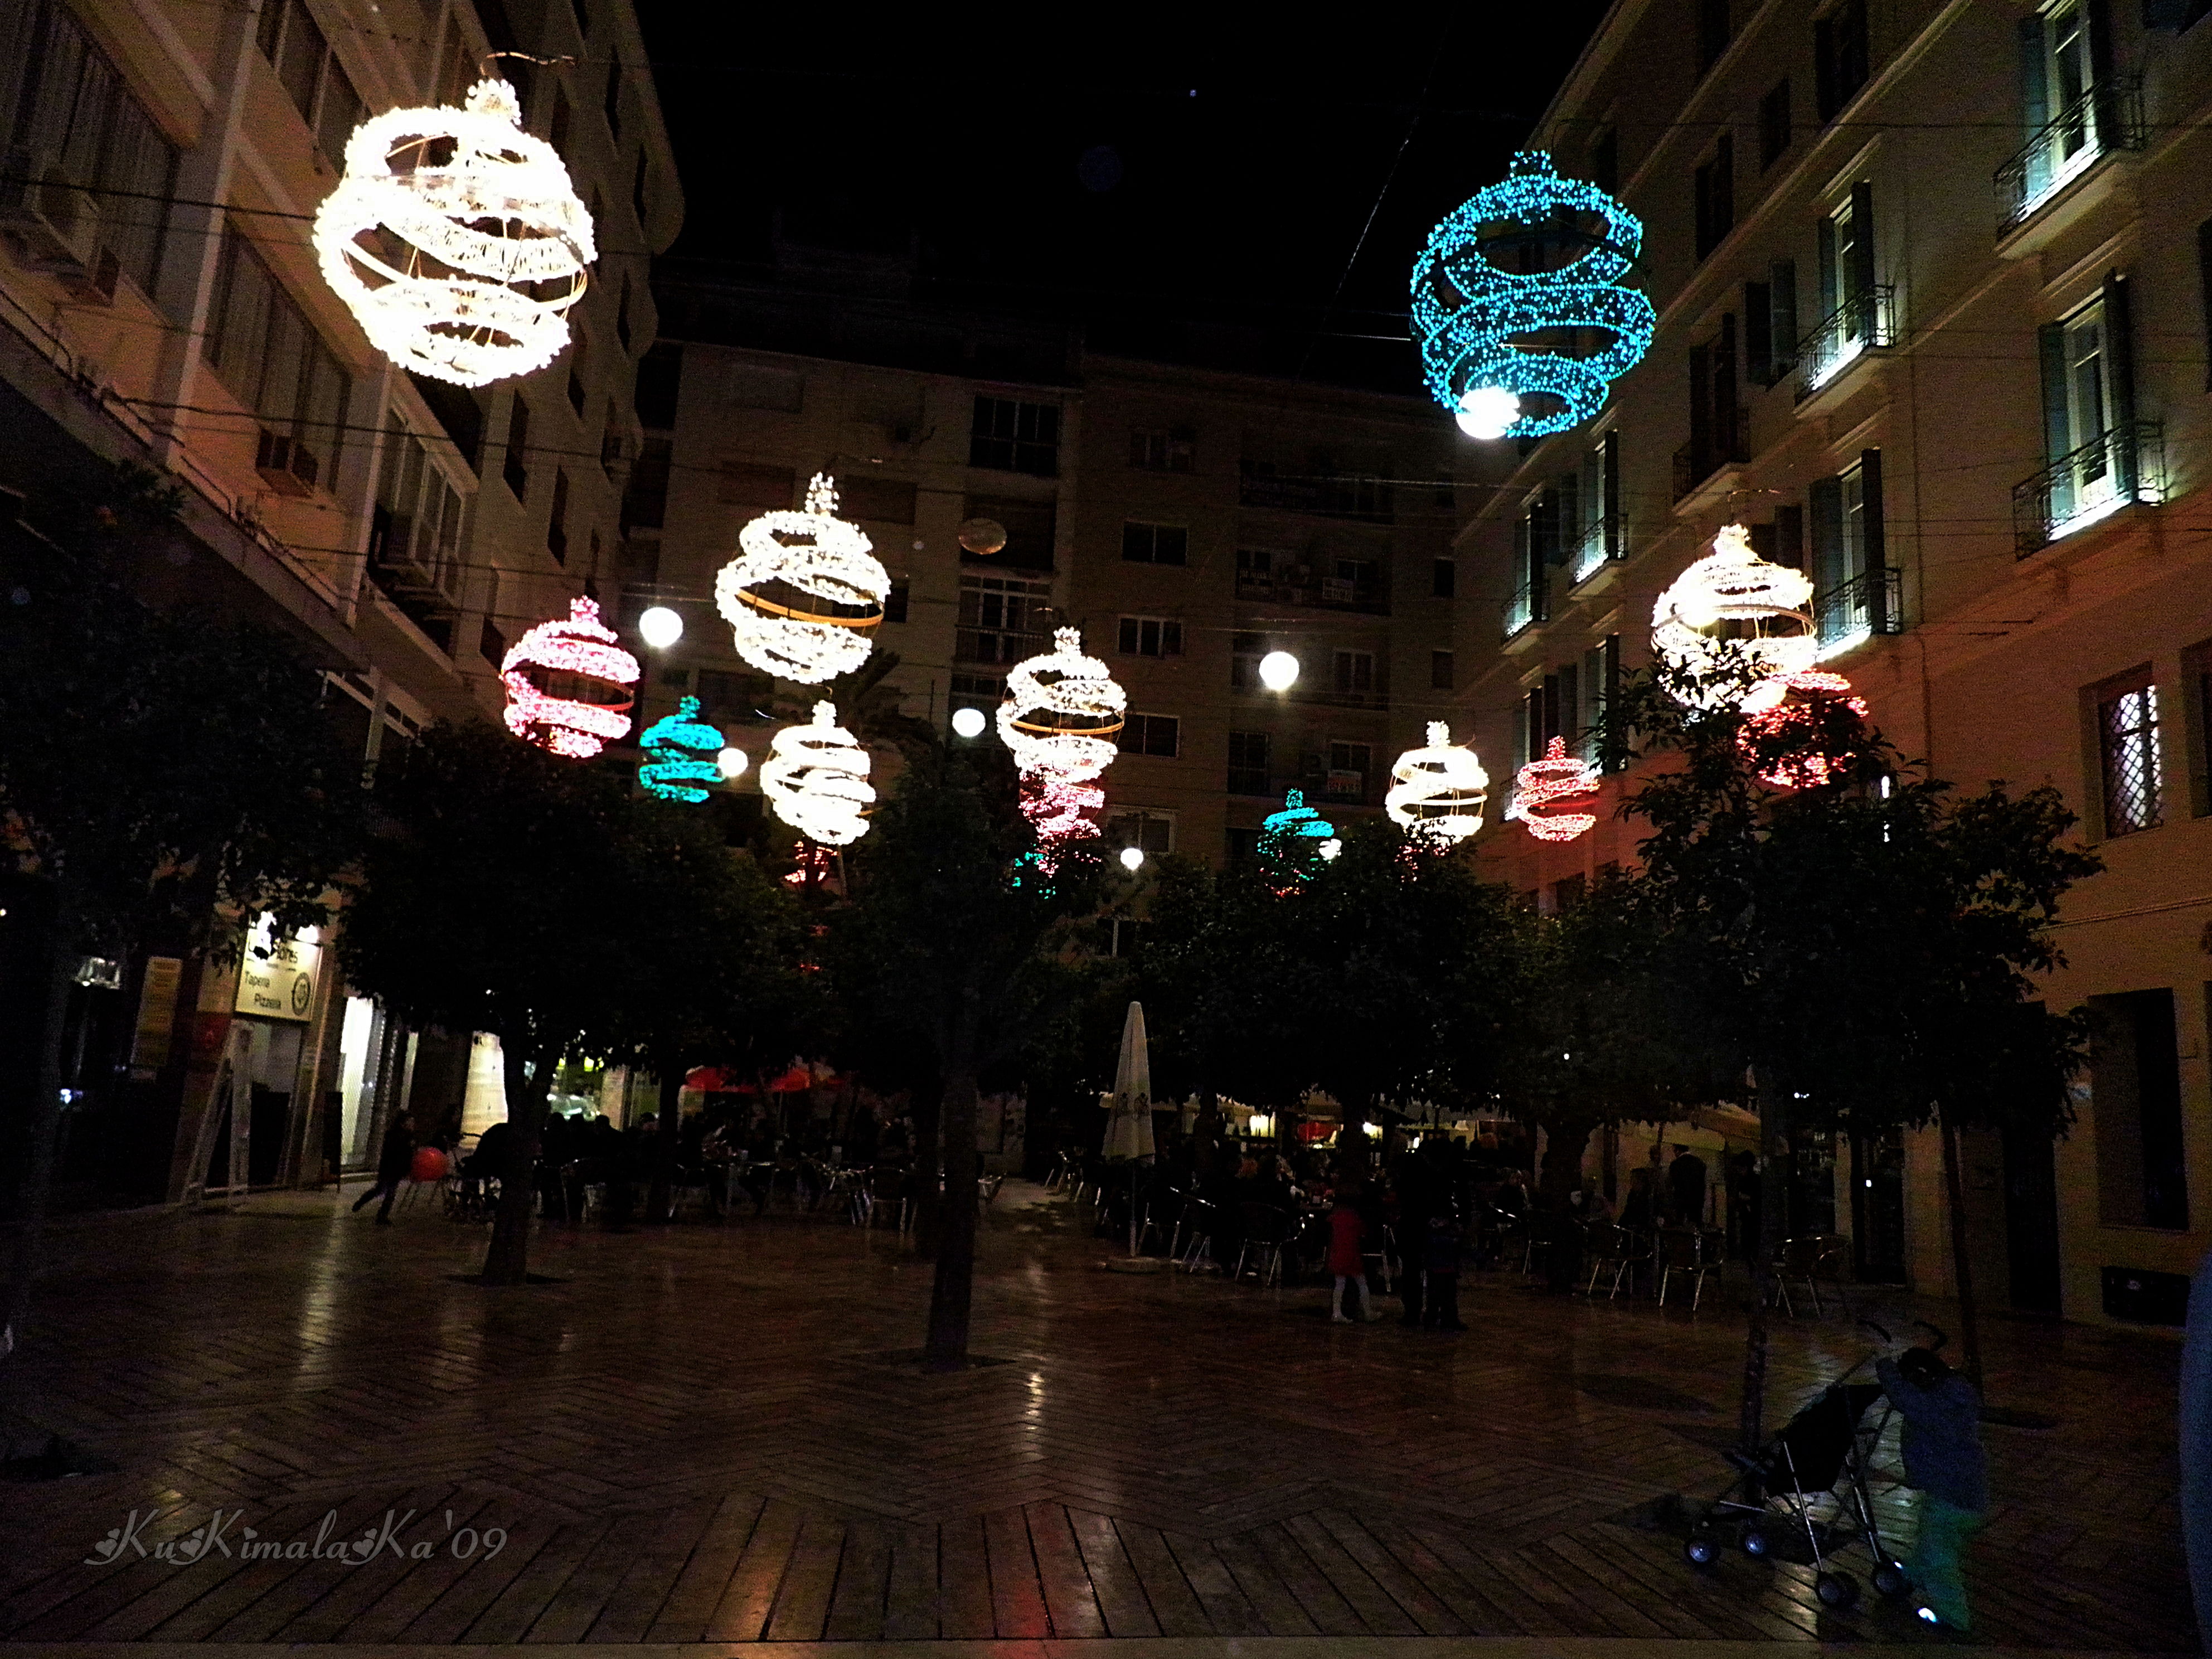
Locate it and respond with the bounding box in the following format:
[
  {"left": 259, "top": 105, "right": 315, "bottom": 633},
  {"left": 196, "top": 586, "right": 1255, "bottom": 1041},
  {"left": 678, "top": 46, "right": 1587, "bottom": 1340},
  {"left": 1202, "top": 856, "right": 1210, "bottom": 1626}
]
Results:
[{"left": 0, "top": 469, "right": 363, "bottom": 1354}]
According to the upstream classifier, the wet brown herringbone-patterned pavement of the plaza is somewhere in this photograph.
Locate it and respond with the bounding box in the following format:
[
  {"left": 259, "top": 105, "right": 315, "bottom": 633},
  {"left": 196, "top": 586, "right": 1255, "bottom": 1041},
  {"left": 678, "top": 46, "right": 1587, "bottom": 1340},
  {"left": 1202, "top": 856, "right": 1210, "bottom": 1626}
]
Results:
[{"left": 0, "top": 1186, "right": 2194, "bottom": 1650}]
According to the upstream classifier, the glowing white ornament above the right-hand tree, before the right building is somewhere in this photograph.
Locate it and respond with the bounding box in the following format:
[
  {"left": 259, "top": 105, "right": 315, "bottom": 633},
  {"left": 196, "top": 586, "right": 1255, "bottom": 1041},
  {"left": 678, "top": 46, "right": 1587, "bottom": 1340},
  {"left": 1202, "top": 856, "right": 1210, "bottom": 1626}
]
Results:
[{"left": 1652, "top": 524, "right": 1821, "bottom": 710}]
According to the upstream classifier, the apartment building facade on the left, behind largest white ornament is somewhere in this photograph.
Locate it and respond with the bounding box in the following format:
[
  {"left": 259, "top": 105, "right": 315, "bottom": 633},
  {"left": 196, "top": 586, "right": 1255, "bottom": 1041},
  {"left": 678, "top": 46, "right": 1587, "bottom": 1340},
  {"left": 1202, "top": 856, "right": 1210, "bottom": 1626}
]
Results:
[{"left": 0, "top": 0, "right": 681, "bottom": 1197}]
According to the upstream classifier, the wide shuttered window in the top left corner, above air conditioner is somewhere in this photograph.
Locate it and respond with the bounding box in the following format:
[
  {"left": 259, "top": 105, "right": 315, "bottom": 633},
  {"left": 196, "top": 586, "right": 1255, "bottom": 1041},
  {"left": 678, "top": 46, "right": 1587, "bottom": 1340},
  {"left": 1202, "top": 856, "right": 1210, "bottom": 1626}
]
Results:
[{"left": 0, "top": 0, "right": 177, "bottom": 294}]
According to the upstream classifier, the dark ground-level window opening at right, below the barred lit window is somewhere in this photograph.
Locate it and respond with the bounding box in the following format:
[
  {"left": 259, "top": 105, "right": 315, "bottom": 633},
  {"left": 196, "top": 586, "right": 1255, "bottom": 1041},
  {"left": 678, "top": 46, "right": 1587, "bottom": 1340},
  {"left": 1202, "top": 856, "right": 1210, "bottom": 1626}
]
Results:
[{"left": 2088, "top": 987, "right": 2190, "bottom": 1230}]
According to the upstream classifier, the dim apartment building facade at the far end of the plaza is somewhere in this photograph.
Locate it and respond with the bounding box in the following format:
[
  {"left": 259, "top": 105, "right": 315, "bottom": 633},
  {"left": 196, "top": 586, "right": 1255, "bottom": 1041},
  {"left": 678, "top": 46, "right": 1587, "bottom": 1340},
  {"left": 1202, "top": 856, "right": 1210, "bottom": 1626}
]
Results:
[{"left": 641, "top": 252, "right": 1464, "bottom": 863}]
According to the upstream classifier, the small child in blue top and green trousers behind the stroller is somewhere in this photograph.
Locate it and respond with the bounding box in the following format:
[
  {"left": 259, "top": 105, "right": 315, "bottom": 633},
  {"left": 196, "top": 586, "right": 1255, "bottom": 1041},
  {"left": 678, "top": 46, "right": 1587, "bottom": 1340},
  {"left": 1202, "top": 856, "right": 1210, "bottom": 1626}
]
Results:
[{"left": 1874, "top": 1338, "right": 1988, "bottom": 1630}]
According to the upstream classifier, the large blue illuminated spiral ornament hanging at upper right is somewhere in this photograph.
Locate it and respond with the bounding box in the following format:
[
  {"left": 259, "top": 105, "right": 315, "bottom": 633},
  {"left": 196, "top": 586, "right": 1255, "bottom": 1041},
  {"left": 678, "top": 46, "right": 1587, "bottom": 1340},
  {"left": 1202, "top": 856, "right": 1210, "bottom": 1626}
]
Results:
[{"left": 1414, "top": 151, "right": 1659, "bottom": 438}]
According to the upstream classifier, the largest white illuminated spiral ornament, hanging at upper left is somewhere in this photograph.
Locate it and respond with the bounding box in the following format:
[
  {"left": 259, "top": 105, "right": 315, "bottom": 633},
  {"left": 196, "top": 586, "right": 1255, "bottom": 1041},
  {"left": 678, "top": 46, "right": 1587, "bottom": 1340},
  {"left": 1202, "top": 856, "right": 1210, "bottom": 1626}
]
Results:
[{"left": 314, "top": 80, "right": 599, "bottom": 385}]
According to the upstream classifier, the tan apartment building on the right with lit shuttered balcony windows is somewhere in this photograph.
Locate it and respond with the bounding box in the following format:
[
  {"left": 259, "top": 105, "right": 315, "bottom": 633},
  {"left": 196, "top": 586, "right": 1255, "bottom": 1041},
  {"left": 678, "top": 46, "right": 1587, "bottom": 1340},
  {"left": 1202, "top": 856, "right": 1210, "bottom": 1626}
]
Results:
[{"left": 1460, "top": 0, "right": 2212, "bottom": 1323}]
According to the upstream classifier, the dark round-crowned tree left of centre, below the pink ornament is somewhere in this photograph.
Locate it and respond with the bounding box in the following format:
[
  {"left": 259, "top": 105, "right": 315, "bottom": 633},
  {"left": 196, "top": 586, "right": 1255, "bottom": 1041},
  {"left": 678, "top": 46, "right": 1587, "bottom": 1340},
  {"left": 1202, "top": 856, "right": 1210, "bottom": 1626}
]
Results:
[{"left": 338, "top": 724, "right": 672, "bottom": 1285}]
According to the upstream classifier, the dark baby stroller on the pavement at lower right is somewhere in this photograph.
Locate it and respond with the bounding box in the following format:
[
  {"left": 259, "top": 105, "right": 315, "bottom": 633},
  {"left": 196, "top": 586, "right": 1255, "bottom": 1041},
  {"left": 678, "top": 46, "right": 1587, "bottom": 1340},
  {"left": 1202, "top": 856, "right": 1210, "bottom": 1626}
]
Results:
[{"left": 1681, "top": 1321, "right": 1909, "bottom": 1611}]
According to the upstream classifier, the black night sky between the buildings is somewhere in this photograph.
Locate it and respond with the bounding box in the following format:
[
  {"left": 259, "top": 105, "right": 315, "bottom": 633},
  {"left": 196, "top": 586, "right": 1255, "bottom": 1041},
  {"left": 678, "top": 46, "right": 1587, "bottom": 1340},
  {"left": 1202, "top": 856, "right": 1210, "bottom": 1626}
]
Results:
[{"left": 639, "top": 14, "right": 1604, "bottom": 389}]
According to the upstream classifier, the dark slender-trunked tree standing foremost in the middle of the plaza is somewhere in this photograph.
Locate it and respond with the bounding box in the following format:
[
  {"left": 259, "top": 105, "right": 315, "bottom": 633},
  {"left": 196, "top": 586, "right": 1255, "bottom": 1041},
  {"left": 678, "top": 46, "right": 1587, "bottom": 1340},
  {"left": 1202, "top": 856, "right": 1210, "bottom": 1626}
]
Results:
[{"left": 827, "top": 750, "right": 1099, "bottom": 1371}]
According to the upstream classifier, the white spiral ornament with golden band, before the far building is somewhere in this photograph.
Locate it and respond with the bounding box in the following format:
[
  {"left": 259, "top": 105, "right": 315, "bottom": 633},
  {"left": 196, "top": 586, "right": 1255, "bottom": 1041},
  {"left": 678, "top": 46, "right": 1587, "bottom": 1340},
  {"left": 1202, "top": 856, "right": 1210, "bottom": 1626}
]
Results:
[{"left": 715, "top": 473, "right": 891, "bottom": 686}]
